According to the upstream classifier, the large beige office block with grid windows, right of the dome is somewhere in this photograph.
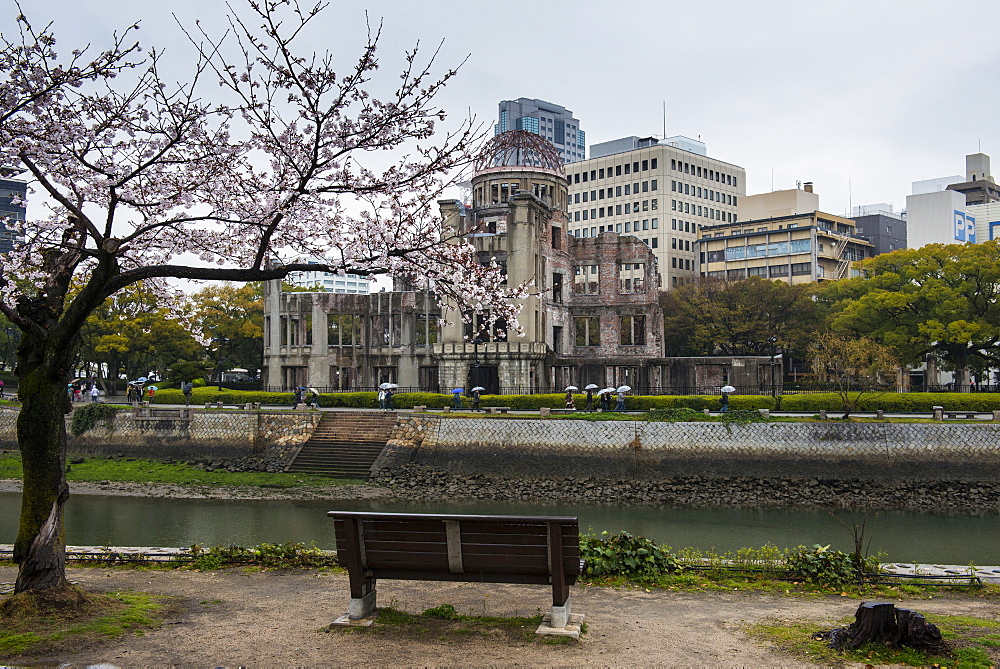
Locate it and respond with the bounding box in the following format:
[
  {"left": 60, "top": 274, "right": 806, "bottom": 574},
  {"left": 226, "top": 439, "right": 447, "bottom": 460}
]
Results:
[{"left": 566, "top": 136, "right": 746, "bottom": 290}]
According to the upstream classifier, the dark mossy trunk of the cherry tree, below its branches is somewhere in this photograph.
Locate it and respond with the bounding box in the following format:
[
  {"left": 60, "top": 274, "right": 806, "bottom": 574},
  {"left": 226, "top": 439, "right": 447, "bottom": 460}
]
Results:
[{"left": 14, "top": 336, "right": 73, "bottom": 592}]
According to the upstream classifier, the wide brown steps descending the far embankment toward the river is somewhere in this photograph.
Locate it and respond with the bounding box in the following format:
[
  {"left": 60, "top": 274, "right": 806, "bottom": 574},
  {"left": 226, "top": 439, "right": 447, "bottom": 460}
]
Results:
[{"left": 285, "top": 411, "right": 396, "bottom": 479}]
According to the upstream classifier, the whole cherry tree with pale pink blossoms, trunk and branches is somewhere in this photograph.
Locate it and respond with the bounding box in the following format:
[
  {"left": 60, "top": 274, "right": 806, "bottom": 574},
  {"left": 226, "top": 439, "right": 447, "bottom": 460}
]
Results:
[{"left": 0, "top": 0, "right": 524, "bottom": 593}]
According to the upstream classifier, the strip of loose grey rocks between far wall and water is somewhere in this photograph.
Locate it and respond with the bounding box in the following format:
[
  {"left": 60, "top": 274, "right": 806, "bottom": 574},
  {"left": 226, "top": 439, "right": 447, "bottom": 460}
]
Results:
[{"left": 376, "top": 464, "right": 1000, "bottom": 513}]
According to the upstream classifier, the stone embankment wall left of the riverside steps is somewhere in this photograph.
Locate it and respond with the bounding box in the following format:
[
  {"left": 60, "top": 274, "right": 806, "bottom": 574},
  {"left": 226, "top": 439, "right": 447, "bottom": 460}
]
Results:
[{"left": 0, "top": 409, "right": 319, "bottom": 471}]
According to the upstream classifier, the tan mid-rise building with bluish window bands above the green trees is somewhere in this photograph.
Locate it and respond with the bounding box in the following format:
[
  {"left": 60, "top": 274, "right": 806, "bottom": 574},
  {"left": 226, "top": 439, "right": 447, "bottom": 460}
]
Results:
[{"left": 696, "top": 183, "right": 873, "bottom": 284}]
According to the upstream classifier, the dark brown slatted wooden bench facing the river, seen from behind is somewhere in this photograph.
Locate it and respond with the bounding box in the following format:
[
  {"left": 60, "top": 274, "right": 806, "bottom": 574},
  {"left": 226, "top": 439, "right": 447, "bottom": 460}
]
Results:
[{"left": 327, "top": 511, "right": 583, "bottom": 630}]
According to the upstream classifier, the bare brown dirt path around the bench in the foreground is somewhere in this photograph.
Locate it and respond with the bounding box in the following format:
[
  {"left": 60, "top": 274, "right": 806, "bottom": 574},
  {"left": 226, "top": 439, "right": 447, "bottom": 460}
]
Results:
[{"left": 0, "top": 567, "right": 1000, "bottom": 667}]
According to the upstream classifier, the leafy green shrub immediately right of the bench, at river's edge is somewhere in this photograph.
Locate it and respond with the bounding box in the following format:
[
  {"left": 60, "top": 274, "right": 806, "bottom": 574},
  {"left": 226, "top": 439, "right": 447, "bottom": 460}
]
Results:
[{"left": 580, "top": 532, "right": 680, "bottom": 579}]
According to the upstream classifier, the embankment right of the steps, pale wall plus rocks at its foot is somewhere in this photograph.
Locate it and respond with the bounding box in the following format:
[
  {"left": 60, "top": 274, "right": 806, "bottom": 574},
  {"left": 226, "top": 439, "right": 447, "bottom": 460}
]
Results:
[{"left": 373, "top": 416, "right": 1000, "bottom": 512}]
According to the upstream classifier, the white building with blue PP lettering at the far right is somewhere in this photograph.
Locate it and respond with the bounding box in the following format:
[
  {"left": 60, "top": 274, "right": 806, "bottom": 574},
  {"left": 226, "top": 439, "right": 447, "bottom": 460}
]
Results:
[{"left": 906, "top": 153, "right": 1000, "bottom": 248}]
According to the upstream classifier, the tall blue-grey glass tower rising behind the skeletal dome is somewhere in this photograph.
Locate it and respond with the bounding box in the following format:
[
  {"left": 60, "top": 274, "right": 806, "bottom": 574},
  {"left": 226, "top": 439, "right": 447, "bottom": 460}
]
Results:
[{"left": 493, "top": 98, "right": 587, "bottom": 163}]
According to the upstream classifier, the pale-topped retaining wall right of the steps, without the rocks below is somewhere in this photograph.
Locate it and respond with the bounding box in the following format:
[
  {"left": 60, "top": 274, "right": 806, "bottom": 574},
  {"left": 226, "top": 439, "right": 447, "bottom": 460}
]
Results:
[{"left": 396, "top": 417, "right": 1000, "bottom": 481}]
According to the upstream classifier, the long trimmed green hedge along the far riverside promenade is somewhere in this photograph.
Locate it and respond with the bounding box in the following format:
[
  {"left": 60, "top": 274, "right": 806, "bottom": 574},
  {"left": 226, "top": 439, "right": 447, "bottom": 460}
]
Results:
[{"left": 153, "top": 387, "right": 1000, "bottom": 413}]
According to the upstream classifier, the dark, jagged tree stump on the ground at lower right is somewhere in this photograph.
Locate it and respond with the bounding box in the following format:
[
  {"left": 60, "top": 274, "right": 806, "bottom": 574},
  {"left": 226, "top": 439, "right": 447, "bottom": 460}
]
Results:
[{"left": 826, "top": 602, "right": 946, "bottom": 652}]
